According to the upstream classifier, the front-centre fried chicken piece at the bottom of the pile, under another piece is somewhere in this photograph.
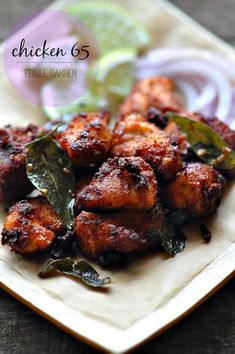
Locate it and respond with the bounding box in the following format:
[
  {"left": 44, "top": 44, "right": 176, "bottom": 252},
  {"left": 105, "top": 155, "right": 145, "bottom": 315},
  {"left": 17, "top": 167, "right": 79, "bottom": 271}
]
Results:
[{"left": 75, "top": 206, "right": 165, "bottom": 258}]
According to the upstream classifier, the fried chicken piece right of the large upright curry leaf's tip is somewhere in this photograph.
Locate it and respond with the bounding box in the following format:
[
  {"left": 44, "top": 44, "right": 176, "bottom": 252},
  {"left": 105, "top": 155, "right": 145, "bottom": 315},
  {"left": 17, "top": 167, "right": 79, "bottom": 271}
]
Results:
[{"left": 58, "top": 112, "right": 111, "bottom": 166}]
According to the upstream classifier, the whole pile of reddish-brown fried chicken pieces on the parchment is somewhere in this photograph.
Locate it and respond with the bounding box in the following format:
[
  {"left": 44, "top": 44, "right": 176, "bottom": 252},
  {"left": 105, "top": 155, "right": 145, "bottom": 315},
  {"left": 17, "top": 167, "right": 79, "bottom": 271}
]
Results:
[{"left": 0, "top": 77, "right": 235, "bottom": 266}]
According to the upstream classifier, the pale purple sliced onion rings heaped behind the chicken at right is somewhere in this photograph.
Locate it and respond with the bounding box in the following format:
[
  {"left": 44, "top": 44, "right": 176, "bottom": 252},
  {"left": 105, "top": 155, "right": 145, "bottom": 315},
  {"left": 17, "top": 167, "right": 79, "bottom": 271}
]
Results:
[{"left": 136, "top": 48, "right": 235, "bottom": 122}]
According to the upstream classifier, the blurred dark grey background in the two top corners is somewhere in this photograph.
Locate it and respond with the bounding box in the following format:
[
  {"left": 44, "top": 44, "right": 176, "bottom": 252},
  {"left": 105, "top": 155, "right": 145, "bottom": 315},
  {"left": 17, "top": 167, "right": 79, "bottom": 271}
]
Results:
[{"left": 0, "top": 0, "right": 235, "bottom": 45}]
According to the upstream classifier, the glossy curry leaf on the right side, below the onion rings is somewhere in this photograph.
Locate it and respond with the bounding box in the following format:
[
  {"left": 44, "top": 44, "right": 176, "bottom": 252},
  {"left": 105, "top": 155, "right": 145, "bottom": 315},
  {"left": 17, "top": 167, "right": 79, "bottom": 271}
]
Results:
[{"left": 167, "top": 112, "right": 235, "bottom": 170}]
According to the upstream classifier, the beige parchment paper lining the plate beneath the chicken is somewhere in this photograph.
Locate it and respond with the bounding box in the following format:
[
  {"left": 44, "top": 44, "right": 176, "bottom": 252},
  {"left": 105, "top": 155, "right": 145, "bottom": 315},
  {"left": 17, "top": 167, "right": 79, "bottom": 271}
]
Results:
[{"left": 0, "top": 0, "right": 235, "bottom": 329}]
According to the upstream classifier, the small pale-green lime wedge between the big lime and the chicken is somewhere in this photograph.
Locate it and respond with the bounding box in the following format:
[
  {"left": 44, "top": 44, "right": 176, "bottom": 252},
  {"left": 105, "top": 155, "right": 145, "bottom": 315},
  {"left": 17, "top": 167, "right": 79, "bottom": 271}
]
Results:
[{"left": 87, "top": 49, "right": 136, "bottom": 97}]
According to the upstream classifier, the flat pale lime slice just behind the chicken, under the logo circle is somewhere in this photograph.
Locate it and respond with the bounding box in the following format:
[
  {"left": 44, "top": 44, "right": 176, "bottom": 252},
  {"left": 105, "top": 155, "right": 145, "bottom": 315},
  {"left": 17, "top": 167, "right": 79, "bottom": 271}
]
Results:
[{"left": 42, "top": 88, "right": 107, "bottom": 121}]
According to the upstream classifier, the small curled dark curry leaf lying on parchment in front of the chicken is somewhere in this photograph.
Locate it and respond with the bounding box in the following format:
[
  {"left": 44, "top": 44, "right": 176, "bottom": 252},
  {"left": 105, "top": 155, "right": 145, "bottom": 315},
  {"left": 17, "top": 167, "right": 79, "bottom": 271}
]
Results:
[{"left": 38, "top": 258, "right": 111, "bottom": 288}]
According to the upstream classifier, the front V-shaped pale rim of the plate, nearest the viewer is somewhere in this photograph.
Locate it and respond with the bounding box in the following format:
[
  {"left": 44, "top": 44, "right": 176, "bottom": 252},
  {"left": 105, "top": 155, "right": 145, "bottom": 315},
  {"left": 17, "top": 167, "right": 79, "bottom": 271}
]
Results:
[{"left": 0, "top": 242, "right": 235, "bottom": 354}]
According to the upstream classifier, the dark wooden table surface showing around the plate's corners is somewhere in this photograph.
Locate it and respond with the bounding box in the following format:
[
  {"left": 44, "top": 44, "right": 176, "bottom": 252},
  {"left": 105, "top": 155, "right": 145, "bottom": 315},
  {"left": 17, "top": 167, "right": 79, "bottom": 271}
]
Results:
[{"left": 0, "top": 0, "right": 235, "bottom": 354}]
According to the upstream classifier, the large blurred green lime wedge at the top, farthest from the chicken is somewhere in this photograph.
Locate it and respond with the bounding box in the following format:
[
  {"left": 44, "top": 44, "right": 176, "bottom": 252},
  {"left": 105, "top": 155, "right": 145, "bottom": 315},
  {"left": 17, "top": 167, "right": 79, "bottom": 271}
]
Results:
[{"left": 67, "top": 2, "right": 150, "bottom": 54}]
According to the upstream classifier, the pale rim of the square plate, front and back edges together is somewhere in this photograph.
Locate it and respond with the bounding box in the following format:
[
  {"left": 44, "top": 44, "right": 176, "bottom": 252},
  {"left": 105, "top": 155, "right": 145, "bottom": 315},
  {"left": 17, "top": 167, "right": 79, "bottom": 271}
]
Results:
[{"left": 0, "top": 0, "right": 235, "bottom": 354}]
